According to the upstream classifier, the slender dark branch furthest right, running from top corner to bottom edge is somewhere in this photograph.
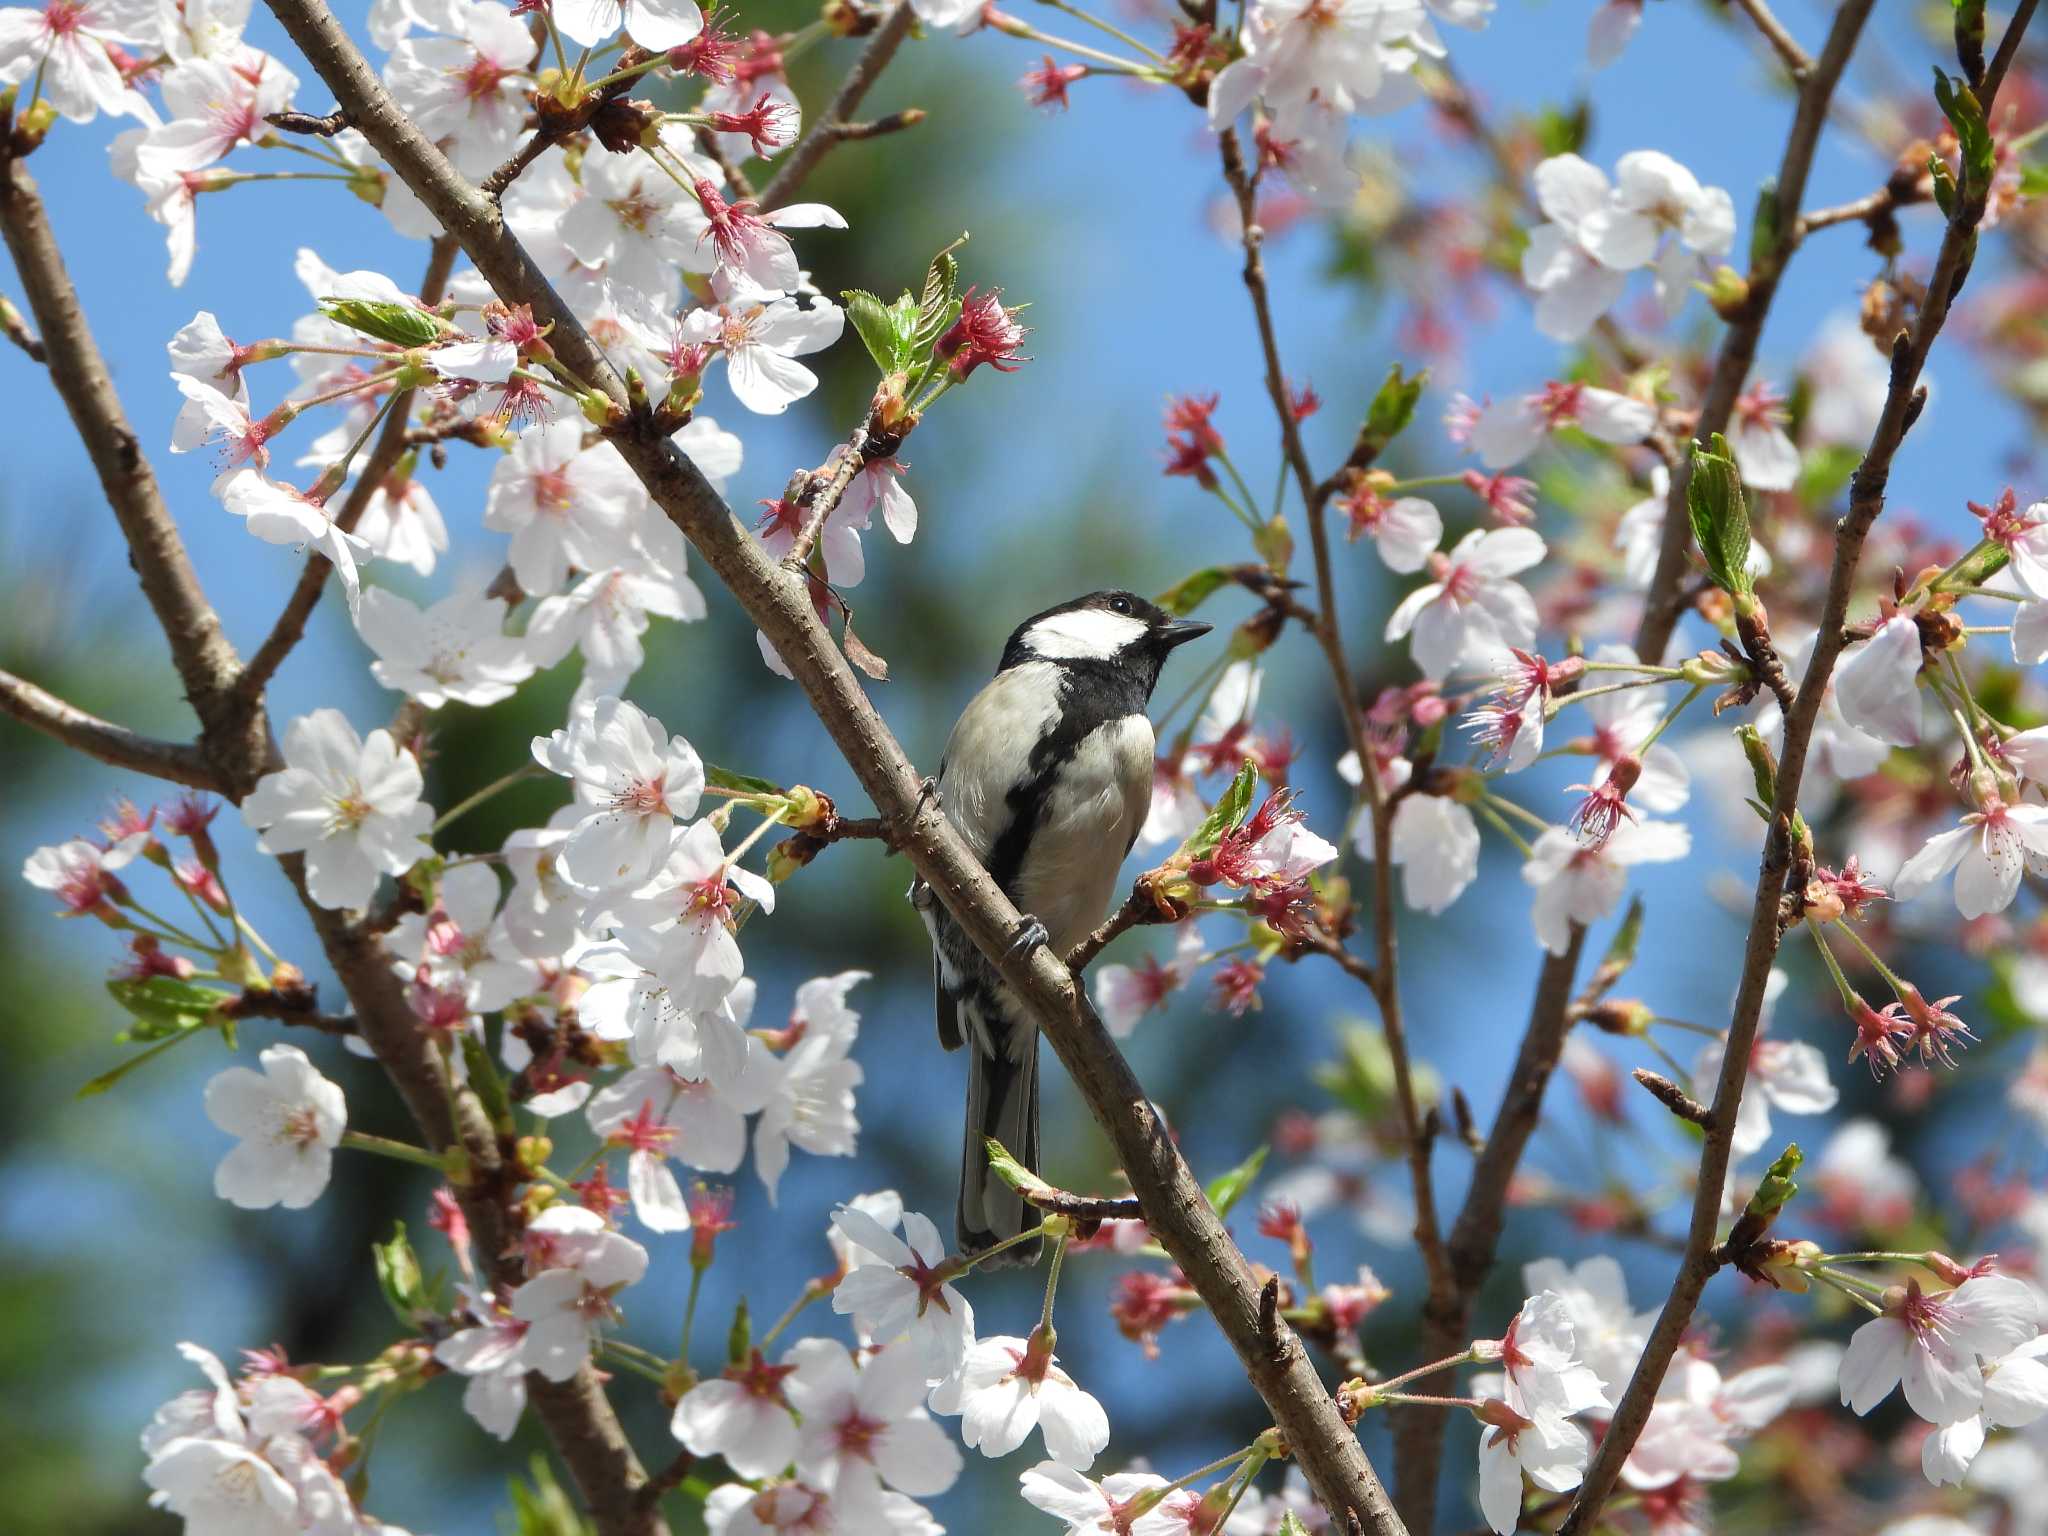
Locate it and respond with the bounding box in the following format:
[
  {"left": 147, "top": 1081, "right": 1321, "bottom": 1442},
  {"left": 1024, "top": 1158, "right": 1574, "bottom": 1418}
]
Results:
[{"left": 1559, "top": 0, "right": 2036, "bottom": 1536}]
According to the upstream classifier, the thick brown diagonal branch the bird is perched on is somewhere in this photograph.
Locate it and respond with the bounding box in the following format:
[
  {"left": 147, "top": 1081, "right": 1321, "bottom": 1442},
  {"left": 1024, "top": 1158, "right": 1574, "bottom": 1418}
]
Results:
[{"left": 268, "top": 0, "right": 1405, "bottom": 1536}]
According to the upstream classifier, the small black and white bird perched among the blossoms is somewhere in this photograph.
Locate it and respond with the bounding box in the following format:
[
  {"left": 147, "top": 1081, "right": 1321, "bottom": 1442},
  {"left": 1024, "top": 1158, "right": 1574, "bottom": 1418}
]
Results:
[{"left": 911, "top": 592, "right": 1208, "bottom": 1264}]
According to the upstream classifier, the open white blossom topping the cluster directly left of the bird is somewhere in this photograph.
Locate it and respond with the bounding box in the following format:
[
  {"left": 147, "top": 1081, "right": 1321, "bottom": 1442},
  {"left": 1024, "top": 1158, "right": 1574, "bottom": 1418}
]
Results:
[{"left": 532, "top": 696, "right": 715, "bottom": 891}]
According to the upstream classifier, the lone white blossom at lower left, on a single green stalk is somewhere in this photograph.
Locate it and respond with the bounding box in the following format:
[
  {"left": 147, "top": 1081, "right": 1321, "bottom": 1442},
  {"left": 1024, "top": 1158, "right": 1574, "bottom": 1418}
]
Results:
[{"left": 207, "top": 1044, "right": 348, "bottom": 1210}]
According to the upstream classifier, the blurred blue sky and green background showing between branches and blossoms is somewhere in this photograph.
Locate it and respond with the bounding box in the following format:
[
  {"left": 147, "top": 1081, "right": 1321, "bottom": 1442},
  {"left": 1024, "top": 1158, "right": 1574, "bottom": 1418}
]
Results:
[{"left": 0, "top": 0, "right": 2032, "bottom": 1536}]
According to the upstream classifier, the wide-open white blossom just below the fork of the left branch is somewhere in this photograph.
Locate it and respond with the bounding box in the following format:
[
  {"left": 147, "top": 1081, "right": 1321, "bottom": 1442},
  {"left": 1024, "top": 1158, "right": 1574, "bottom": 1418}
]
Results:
[{"left": 242, "top": 709, "right": 434, "bottom": 907}]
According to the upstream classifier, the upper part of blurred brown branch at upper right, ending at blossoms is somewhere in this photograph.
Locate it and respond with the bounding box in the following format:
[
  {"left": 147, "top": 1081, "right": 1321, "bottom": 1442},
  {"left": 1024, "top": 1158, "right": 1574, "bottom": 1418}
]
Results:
[{"left": 1636, "top": 0, "right": 1876, "bottom": 662}]
